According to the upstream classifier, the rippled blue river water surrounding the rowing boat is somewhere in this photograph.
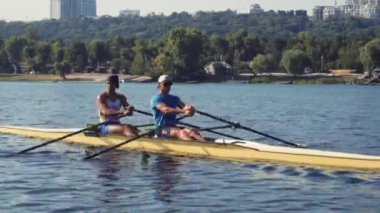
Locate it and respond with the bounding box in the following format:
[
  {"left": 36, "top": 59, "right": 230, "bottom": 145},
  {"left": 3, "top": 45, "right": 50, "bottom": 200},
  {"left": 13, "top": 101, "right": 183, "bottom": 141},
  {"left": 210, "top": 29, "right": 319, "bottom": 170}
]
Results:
[{"left": 0, "top": 82, "right": 380, "bottom": 212}]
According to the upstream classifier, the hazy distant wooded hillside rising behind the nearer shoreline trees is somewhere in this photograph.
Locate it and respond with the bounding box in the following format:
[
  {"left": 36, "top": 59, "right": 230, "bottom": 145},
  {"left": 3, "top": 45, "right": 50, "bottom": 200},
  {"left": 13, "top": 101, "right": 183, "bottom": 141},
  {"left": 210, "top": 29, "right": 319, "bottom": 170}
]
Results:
[{"left": 0, "top": 10, "right": 380, "bottom": 43}]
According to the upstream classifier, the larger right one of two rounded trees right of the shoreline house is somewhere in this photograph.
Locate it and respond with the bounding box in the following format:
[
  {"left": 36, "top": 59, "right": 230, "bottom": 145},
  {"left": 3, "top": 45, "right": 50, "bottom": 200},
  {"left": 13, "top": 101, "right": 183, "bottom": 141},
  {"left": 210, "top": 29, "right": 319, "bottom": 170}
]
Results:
[{"left": 281, "top": 50, "right": 310, "bottom": 75}]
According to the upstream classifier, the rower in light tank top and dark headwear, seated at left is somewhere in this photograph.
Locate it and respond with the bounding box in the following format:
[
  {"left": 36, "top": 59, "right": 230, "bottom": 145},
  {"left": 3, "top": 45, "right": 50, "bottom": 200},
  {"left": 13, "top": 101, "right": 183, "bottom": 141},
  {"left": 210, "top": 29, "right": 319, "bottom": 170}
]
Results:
[{"left": 96, "top": 75, "right": 138, "bottom": 137}]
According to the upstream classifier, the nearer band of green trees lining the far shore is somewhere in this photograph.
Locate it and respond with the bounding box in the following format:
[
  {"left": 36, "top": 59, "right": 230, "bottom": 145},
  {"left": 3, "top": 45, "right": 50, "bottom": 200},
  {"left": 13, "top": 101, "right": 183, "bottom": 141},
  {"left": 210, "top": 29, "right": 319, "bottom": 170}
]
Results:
[{"left": 0, "top": 25, "right": 380, "bottom": 81}]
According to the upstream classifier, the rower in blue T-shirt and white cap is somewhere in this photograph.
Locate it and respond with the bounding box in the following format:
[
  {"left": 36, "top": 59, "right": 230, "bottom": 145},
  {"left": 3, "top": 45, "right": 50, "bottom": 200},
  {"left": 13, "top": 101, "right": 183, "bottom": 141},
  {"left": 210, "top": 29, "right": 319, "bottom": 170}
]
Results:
[{"left": 150, "top": 75, "right": 205, "bottom": 141}]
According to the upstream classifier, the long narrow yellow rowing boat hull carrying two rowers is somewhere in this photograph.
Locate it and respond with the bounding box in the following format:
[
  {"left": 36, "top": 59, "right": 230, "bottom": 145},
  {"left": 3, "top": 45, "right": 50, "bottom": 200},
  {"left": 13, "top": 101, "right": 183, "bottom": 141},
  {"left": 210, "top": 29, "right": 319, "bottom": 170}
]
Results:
[{"left": 0, "top": 125, "right": 380, "bottom": 171}]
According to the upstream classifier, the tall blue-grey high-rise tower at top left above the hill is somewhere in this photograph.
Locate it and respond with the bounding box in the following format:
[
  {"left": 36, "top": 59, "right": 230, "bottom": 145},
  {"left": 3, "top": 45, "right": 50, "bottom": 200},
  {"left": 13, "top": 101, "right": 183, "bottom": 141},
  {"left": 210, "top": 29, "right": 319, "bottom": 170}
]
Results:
[{"left": 50, "top": 0, "right": 96, "bottom": 19}]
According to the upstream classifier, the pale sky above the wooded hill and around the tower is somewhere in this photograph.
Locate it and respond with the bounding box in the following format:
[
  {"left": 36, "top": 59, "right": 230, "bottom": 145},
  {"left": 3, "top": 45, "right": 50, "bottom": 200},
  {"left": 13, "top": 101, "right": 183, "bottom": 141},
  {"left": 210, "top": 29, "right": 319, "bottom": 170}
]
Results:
[{"left": 0, "top": 0, "right": 344, "bottom": 21}]
